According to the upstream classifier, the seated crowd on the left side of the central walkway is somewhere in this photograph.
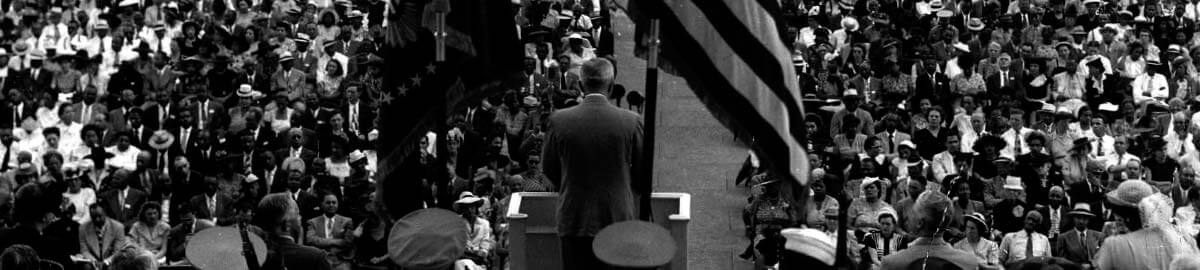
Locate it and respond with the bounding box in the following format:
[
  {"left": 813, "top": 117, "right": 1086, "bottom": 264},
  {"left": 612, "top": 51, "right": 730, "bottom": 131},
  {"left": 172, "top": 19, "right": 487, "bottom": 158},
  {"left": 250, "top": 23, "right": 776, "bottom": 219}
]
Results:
[{"left": 0, "top": 0, "right": 619, "bottom": 270}]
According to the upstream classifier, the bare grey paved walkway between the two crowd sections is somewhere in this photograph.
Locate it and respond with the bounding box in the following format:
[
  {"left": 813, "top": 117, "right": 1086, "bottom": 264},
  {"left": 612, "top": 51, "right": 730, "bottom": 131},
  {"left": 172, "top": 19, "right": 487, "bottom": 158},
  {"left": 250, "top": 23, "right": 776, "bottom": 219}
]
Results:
[{"left": 613, "top": 12, "right": 752, "bottom": 270}]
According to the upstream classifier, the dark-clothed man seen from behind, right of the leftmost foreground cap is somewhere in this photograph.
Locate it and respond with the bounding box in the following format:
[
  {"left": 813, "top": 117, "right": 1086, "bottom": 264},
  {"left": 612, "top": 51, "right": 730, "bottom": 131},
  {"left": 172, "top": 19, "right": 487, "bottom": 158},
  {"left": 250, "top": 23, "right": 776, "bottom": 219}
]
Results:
[{"left": 252, "top": 193, "right": 332, "bottom": 270}]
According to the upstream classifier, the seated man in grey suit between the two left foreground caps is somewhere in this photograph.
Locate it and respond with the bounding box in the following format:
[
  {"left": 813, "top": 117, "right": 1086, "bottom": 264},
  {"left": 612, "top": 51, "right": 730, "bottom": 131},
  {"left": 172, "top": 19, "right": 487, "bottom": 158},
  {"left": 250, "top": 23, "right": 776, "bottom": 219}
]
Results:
[{"left": 305, "top": 194, "right": 354, "bottom": 270}]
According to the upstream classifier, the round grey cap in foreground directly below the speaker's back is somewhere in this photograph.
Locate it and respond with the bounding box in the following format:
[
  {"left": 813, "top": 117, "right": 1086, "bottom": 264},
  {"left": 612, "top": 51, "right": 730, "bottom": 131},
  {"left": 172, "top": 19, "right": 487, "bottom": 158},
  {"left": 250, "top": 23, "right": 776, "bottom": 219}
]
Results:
[{"left": 592, "top": 221, "right": 678, "bottom": 268}]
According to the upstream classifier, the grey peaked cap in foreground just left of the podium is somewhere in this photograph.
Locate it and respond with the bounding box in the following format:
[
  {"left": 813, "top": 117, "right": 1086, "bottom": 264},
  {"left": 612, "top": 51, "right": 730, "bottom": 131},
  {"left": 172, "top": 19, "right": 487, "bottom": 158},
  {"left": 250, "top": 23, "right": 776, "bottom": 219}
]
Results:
[{"left": 388, "top": 208, "right": 468, "bottom": 270}]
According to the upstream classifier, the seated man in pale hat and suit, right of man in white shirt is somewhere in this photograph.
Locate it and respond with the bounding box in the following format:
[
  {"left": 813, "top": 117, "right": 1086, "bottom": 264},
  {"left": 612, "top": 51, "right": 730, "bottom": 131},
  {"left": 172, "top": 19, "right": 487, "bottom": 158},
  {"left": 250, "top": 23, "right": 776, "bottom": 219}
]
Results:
[{"left": 1052, "top": 203, "right": 1104, "bottom": 268}]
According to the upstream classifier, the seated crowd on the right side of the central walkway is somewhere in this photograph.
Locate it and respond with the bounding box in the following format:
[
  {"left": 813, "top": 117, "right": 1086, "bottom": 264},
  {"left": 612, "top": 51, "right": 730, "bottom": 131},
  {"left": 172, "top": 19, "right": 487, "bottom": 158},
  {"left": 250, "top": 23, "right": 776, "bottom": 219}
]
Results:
[{"left": 738, "top": 0, "right": 1200, "bottom": 269}]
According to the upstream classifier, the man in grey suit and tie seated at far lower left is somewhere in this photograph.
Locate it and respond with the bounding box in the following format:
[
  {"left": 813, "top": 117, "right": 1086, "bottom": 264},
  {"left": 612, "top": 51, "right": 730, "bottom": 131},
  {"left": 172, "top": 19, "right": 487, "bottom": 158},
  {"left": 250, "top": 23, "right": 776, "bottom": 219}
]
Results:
[{"left": 79, "top": 200, "right": 127, "bottom": 269}]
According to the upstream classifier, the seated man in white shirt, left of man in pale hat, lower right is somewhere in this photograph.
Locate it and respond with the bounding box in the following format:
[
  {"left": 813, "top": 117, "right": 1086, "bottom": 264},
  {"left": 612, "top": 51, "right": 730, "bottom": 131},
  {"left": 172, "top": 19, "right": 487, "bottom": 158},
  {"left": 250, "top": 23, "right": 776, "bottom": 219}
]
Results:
[{"left": 1000, "top": 210, "right": 1051, "bottom": 264}]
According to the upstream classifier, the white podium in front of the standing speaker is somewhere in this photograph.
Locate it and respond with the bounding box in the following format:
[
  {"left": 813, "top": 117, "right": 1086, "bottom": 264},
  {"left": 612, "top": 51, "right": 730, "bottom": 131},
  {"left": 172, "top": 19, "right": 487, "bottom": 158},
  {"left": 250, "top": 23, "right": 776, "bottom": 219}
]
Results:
[{"left": 505, "top": 192, "right": 691, "bottom": 270}]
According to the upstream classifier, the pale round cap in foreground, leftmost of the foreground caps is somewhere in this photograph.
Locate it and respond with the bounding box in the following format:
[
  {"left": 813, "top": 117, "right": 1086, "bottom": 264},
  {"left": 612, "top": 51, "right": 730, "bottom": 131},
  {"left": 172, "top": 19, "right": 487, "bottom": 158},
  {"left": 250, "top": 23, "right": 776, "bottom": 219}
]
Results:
[{"left": 185, "top": 227, "right": 266, "bottom": 270}]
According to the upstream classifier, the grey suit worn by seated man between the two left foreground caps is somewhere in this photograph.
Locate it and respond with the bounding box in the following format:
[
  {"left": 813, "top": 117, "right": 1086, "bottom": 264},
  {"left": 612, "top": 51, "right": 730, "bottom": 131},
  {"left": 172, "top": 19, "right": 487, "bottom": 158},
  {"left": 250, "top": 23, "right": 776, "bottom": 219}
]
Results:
[{"left": 305, "top": 215, "right": 354, "bottom": 265}]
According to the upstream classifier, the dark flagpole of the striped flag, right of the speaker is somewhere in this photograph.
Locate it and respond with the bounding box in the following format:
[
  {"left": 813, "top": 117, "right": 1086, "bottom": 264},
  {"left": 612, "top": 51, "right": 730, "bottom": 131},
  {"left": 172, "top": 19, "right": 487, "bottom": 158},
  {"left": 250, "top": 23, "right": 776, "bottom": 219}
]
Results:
[{"left": 640, "top": 18, "right": 660, "bottom": 221}]
